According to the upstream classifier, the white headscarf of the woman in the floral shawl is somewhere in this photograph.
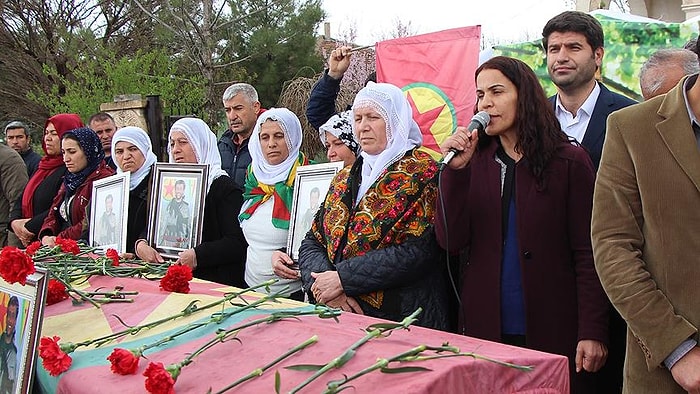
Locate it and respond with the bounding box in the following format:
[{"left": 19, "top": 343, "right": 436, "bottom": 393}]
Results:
[{"left": 352, "top": 82, "right": 423, "bottom": 205}]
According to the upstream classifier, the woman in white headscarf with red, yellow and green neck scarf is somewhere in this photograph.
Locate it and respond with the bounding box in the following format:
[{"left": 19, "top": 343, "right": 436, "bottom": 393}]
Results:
[{"left": 239, "top": 108, "right": 309, "bottom": 300}]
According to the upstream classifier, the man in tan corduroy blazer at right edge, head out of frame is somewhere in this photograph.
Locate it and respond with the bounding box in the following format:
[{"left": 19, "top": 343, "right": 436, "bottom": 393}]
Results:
[{"left": 591, "top": 74, "right": 700, "bottom": 394}]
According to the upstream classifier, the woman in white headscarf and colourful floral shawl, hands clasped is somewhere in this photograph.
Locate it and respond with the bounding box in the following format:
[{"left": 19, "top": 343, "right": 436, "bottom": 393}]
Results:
[{"left": 299, "top": 83, "right": 448, "bottom": 329}]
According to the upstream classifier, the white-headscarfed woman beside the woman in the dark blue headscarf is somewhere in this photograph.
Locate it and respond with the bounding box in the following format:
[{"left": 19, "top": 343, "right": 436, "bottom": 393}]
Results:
[{"left": 112, "top": 126, "right": 157, "bottom": 253}]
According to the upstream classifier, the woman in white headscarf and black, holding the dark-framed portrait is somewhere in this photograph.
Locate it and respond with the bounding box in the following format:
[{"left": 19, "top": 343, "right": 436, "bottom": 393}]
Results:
[{"left": 136, "top": 118, "right": 246, "bottom": 288}]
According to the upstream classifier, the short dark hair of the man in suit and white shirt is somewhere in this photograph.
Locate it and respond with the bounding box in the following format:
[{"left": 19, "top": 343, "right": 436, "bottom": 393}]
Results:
[{"left": 542, "top": 11, "right": 605, "bottom": 52}]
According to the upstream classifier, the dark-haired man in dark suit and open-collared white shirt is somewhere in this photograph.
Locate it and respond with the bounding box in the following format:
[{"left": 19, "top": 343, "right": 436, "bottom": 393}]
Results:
[{"left": 542, "top": 11, "right": 636, "bottom": 393}]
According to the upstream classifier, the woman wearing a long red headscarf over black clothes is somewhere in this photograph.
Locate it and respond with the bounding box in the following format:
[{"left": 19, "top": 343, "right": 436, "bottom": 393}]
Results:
[{"left": 10, "top": 114, "right": 83, "bottom": 246}]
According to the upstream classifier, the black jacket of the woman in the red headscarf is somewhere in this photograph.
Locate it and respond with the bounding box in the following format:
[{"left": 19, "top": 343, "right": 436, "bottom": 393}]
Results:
[{"left": 10, "top": 165, "right": 66, "bottom": 234}]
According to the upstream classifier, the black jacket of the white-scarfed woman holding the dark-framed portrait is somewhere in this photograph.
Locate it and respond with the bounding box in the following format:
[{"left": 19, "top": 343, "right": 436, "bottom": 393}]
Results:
[{"left": 193, "top": 176, "right": 248, "bottom": 288}]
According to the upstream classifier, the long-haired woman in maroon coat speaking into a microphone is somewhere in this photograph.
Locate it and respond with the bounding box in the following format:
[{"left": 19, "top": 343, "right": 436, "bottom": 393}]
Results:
[{"left": 435, "top": 57, "right": 608, "bottom": 392}]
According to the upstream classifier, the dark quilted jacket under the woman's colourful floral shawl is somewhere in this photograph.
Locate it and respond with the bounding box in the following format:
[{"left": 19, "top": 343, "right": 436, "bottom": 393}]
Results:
[{"left": 299, "top": 227, "right": 449, "bottom": 330}]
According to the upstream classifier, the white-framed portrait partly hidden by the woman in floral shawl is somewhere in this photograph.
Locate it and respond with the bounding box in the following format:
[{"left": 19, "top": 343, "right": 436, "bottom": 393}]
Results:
[{"left": 287, "top": 161, "right": 343, "bottom": 261}]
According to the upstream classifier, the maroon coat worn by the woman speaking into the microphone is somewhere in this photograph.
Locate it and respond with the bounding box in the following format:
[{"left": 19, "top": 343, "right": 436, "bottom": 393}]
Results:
[{"left": 435, "top": 140, "right": 608, "bottom": 360}]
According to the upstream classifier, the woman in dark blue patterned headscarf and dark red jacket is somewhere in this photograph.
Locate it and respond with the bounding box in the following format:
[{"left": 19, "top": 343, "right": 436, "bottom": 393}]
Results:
[{"left": 39, "top": 127, "right": 114, "bottom": 246}]
